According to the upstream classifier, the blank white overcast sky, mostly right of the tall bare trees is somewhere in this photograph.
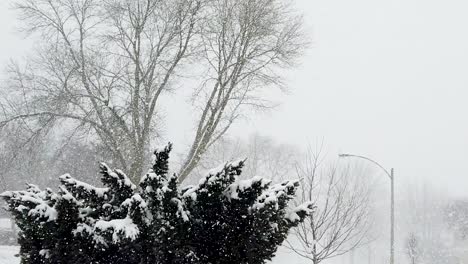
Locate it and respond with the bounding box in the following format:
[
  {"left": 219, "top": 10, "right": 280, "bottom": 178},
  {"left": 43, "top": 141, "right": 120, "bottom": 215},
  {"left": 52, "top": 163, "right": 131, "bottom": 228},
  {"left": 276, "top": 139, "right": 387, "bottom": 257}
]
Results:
[{"left": 0, "top": 0, "right": 468, "bottom": 198}]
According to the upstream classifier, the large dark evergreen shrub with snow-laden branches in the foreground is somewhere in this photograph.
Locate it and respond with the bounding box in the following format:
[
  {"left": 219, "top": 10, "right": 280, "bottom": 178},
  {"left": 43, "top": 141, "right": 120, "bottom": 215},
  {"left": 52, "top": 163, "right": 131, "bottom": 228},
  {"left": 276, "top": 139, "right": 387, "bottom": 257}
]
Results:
[{"left": 2, "top": 144, "right": 313, "bottom": 264}]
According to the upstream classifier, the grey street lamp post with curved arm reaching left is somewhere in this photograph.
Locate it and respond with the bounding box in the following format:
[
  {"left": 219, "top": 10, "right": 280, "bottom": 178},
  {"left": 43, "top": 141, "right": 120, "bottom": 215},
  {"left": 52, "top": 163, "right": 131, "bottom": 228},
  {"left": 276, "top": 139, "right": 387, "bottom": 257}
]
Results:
[{"left": 338, "top": 154, "right": 395, "bottom": 264}]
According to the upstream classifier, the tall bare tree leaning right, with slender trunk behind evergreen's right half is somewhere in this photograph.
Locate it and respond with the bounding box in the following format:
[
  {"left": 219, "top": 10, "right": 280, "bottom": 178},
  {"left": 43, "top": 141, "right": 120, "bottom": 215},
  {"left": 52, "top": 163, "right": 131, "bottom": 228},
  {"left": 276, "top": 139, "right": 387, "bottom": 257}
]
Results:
[{"left": 180, "top": 0, "right": 306, "bottom": 180}]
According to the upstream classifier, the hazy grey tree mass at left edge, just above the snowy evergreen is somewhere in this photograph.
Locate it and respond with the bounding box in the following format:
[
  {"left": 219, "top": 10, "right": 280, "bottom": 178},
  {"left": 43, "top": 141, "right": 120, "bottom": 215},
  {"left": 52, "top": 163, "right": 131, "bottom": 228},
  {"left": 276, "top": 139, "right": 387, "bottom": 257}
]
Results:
[{"left": 0, "top": 121, "right": 106, "bottom": 190}]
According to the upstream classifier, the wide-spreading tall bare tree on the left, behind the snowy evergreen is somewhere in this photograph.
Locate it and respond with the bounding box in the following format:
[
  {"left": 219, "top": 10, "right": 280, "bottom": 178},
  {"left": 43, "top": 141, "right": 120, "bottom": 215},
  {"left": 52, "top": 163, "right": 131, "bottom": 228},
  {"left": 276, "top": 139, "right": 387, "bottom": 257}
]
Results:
[{"left": 3, "top": 0, "right": 201, "bottom": 182}]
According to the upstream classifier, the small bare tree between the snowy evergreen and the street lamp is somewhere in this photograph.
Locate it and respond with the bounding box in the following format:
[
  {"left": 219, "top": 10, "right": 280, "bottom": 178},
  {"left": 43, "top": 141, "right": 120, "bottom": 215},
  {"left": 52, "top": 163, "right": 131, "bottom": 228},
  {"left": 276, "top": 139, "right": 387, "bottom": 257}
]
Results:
[{"left": 287, "top": 148, "right": 370, "bottom": 264}]
